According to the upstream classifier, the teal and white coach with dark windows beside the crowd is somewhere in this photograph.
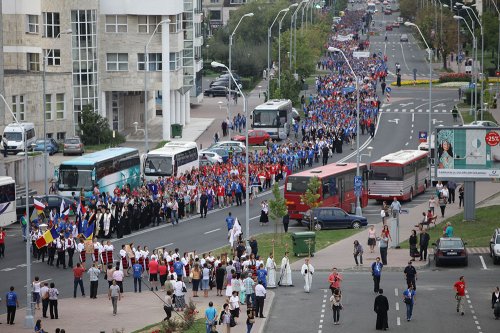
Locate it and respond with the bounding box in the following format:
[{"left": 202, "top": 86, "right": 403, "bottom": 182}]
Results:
[{"left": 55, "top": 147, "right": 141, "bottom": 197}]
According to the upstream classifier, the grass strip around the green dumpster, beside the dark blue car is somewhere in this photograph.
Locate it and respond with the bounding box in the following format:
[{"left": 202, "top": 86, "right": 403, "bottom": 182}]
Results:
[{"left": 212, "top": 226, "right": 364, "bottom": 262}]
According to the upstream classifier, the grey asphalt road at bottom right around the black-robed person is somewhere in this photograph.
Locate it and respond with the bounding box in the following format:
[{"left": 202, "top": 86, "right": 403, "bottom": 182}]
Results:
[{"left": 267, "top": 256, "right": 500, "bottom": 333}]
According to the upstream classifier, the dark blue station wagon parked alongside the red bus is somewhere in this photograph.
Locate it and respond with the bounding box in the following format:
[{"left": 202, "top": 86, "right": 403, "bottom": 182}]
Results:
[{"left": 302, "top": 207, "right": 368, "bottom": 230}]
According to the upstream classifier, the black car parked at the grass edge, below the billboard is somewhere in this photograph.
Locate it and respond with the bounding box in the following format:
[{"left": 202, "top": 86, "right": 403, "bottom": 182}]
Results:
[{"left": 432, "top": 237, "right": 469, "bottom": 267}]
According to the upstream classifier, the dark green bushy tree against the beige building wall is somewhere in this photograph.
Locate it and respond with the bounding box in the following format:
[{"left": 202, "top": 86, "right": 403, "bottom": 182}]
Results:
[{"left": 79, "top": 105, "right": 125, "bottom": 145}]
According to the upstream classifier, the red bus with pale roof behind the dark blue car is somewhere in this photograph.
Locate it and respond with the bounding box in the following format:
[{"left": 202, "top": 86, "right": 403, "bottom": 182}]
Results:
[{"left": 285, "top": 163, "right": 368, "bottom": 222}]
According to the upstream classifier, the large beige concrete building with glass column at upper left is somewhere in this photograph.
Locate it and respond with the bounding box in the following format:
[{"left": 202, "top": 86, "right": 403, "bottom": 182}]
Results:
[{"left": 0, "top": 0, "right": 203, "bottom": 139}]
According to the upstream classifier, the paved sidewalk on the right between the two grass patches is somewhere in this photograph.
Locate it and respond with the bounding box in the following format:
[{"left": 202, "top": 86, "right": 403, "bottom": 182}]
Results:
[{"left": 292, "top": 182, "right": 500, "bottom": 271}]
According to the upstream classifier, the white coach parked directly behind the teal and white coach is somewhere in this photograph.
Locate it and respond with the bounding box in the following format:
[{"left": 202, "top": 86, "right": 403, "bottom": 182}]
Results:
[{"left": 143, "top": 141, "right": 200, "bottom": 180}]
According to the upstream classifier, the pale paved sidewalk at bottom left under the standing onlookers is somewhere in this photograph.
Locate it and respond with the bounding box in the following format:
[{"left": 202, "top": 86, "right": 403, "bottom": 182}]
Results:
[{"left": 0, "top": 288, "right": 275, "bottom": 333}]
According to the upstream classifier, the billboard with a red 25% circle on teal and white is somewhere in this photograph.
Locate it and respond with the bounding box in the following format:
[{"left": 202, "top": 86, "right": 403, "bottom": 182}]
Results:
[{"left": 435, "top": 126, "right": 500, "bottom": 180}]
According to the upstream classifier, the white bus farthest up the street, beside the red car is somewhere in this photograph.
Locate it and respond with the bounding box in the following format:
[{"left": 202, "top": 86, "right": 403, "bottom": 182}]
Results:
[{"left": 250, "top": 99, "right": 300, "bottom": 140}]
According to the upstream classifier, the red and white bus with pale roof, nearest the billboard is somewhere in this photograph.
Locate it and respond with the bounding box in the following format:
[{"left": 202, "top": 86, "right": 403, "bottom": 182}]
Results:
[{"left": 368, "top": 150, "right": 430, "bottom": 201}]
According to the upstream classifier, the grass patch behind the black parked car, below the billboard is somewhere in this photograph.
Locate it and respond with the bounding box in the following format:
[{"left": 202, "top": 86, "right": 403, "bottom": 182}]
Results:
[{"left": 401, "top": 205, "right": 500, "bottom": 249}]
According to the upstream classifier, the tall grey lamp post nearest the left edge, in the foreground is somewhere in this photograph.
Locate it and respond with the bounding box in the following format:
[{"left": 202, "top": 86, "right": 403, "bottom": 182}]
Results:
[{"left": 0, "top": 94, "right": 32, "bottom": 329}]
